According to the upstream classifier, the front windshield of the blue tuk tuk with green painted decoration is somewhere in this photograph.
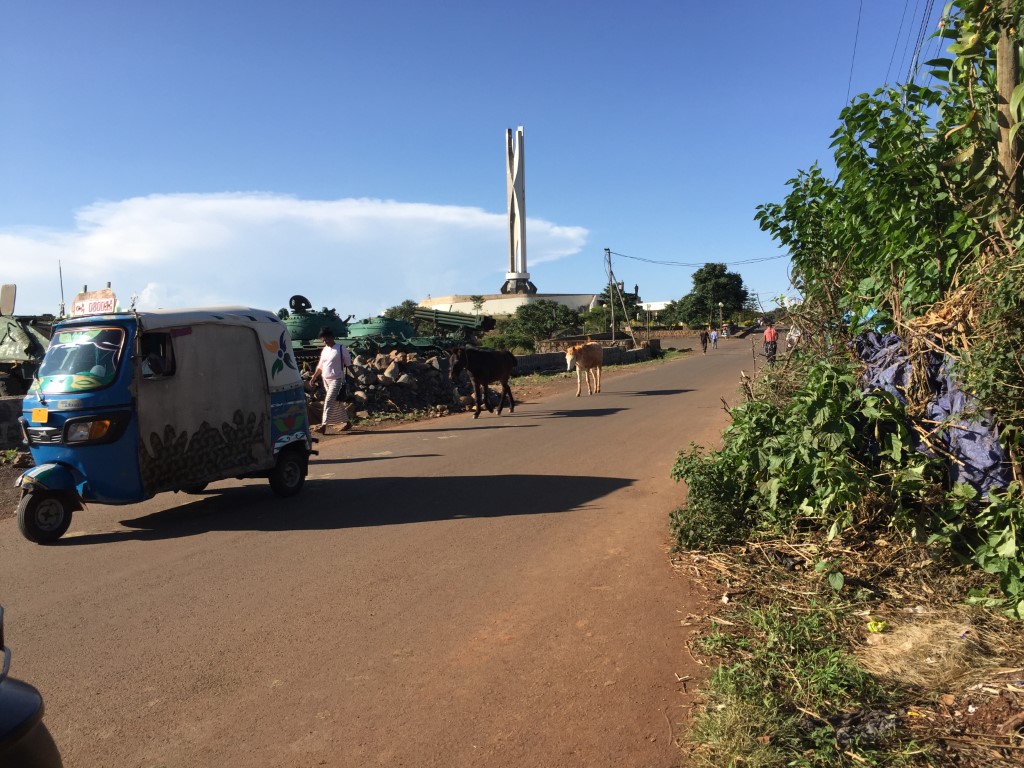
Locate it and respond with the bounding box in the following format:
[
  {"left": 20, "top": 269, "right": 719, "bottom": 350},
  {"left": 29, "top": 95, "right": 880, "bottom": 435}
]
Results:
[{"left": 39, "top": 327, "right": 125, "bottom": 394}]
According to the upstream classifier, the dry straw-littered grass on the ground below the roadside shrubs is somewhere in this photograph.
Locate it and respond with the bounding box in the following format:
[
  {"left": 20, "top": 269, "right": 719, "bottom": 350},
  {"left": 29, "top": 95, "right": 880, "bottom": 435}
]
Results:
[{"left": 676, "top": 531, "right": 1024, "bottom": 768}]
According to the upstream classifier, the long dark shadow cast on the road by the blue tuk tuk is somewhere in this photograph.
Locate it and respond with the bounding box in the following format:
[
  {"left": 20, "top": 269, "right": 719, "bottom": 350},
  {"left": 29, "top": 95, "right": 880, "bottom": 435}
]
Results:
[{"left": 53, "top": 475, "right": 634, "bottom": 547}]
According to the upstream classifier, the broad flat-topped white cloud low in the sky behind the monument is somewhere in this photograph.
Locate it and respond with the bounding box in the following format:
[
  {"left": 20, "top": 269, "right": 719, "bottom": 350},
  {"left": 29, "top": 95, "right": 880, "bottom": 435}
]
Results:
[{"left": 0, "top": 194, "right": 588, "bottom": 317}]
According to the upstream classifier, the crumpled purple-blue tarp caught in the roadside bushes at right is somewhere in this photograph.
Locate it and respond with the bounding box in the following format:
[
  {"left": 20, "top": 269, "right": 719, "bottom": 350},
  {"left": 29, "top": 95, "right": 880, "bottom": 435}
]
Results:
[{"left": 856, "top": 331, "right": 1013, "bottom": 494}]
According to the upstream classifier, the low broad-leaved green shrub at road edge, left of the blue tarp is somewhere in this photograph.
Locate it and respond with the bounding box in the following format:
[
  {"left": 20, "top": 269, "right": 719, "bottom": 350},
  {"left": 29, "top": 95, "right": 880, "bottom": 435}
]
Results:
[{"left": 672, "top": 360, "right": 938, "bottom": 549}]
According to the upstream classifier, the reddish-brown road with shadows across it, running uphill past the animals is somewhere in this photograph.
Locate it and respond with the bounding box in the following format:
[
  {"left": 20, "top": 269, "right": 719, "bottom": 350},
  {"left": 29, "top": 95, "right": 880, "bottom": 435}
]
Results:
[{"left": 0, "top": 340, "right": 751, "bottom": 768}]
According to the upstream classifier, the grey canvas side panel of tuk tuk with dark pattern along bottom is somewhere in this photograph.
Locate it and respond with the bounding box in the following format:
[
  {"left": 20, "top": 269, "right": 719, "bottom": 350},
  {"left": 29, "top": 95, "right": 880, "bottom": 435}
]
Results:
[{"left": 138, "top": 324, "right": 273, "bottom": 493}]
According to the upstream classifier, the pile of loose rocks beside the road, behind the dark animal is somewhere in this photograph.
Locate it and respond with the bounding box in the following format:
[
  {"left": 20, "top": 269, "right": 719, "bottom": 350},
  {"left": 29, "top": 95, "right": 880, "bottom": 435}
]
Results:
[{"left": 303, "top": 351, "right": 472, "bottom": 418}]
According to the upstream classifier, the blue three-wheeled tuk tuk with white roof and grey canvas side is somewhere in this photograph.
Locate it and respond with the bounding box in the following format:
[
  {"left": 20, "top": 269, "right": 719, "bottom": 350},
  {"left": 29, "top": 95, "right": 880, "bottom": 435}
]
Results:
[{"left": 17, "top": 307, "right": 314, "bottom": 544}]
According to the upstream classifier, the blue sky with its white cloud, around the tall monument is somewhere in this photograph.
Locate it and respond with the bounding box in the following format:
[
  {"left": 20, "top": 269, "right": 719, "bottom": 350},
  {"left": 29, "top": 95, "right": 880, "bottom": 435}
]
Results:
[{"left": 0, "top": 0, "right": 941, "bottom": 317}]
